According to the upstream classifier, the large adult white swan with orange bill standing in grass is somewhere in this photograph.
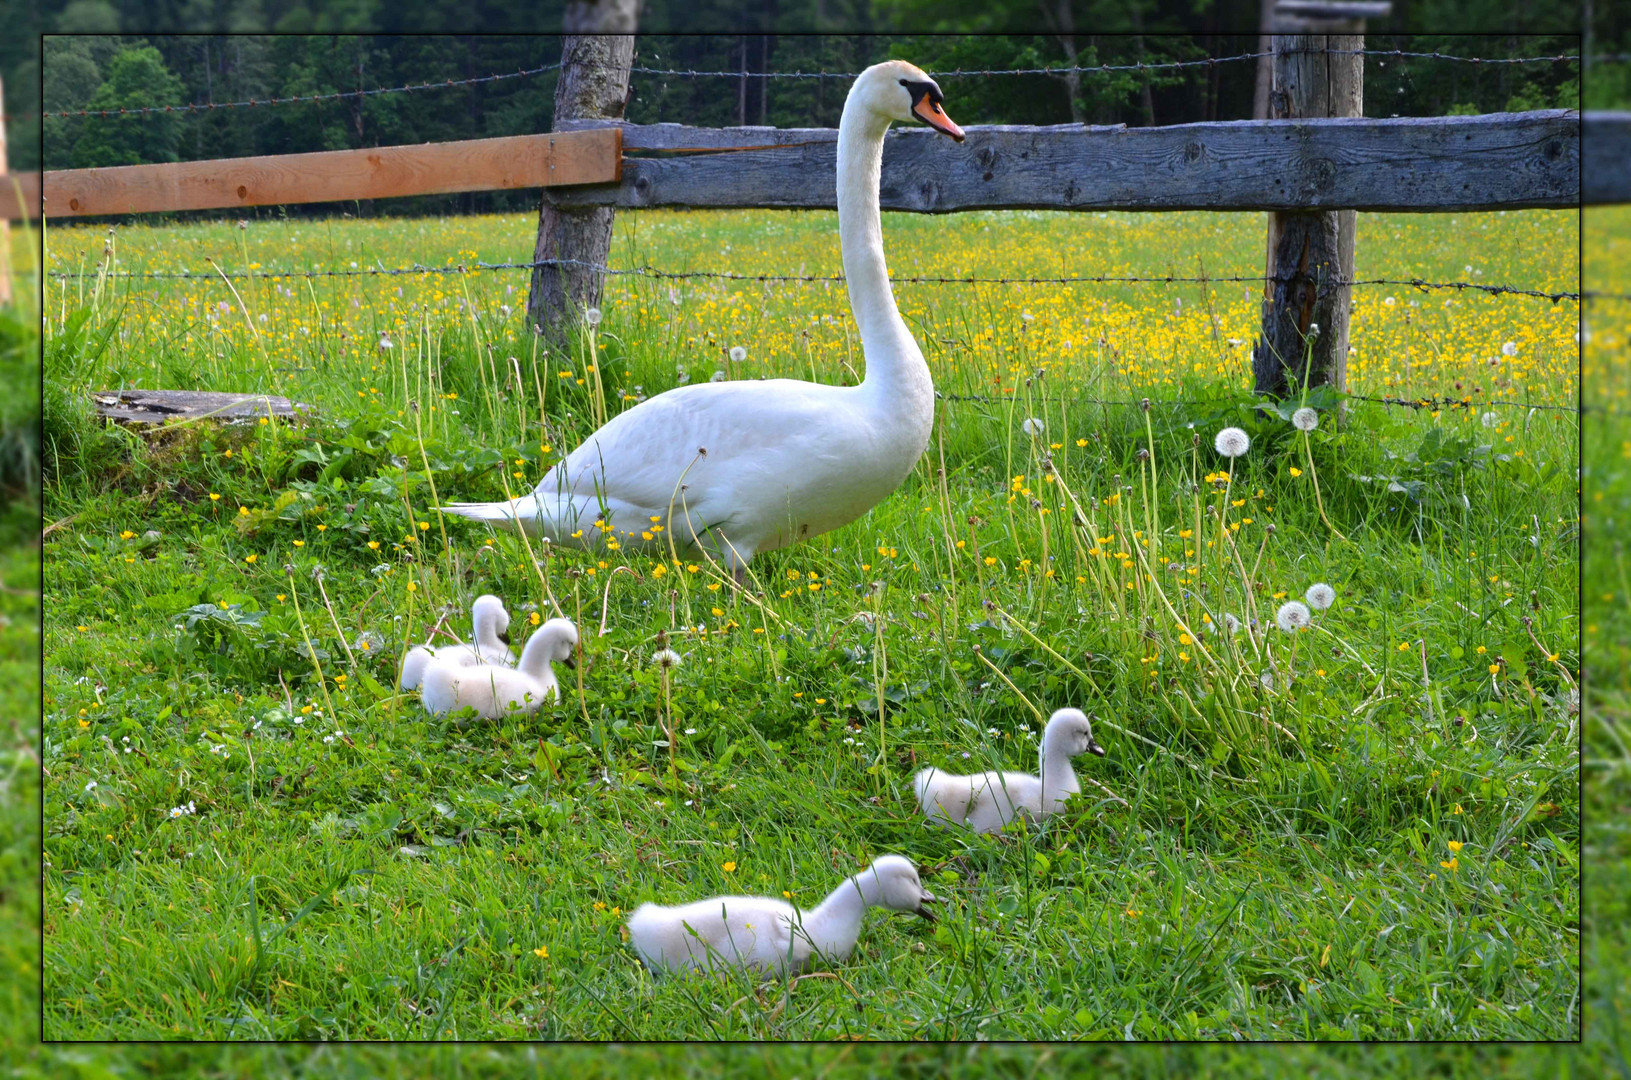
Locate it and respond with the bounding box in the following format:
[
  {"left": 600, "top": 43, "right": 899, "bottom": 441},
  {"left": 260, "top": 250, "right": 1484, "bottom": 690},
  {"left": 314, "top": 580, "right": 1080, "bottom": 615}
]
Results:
[{"left": 445, "top": 60, "right": 962, "bottom": 581}]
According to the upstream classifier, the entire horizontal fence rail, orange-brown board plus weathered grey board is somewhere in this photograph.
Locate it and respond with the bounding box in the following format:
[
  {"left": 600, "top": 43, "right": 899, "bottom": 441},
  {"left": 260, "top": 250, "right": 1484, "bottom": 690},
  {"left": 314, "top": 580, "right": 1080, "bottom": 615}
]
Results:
[{"left": 9, "top": 111, "right": 1604, "bottom": 219}]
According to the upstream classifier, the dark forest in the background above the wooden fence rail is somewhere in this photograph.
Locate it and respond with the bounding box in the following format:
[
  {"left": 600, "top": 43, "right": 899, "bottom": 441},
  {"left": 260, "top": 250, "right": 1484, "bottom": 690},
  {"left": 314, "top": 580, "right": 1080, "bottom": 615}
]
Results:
[{"left": 0, "top": 0, "right": 1604, "bottom": 188}]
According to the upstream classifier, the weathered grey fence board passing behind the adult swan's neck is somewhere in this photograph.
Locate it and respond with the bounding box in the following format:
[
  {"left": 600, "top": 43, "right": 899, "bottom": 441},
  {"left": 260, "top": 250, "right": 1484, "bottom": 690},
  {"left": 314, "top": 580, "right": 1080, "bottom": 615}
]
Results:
[{"left": 553, "top": 111, "right": 1580, "bottom": 214}]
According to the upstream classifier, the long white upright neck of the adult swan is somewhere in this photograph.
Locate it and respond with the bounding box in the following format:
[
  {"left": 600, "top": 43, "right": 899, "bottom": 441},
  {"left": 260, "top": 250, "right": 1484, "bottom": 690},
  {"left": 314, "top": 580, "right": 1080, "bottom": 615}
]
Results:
[{"left": 838, "top": 95, "right": 935, "bottom": 414}]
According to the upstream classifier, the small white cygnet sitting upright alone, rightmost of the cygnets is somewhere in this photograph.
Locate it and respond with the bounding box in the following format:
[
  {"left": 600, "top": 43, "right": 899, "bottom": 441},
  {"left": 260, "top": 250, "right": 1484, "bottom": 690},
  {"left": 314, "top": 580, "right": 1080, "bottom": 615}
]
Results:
[{"left": 912, "top": 708, "right": 1104, "bottom": 832}]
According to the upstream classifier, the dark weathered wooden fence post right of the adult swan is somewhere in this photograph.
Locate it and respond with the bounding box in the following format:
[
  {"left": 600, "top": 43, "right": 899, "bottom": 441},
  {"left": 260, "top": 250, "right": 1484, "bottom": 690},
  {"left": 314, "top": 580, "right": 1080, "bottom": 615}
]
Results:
[{"left": 1251, "top": 0, "right": 1390, "bottom": 396}]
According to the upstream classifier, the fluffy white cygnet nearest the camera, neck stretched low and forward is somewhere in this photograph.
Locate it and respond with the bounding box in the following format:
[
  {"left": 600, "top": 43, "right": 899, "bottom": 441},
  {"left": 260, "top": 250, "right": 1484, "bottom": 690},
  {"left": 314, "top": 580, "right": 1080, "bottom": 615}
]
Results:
[{"left": 628, "top": 855, "right": 936, "bottom": 972}]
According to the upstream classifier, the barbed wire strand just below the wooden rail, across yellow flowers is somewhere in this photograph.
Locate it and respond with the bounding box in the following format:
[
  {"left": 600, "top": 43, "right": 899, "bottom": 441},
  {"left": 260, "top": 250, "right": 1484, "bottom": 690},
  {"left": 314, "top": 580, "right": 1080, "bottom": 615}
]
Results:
[{"left": 47, "top": 259, "right": 1580, "bottom": 303}]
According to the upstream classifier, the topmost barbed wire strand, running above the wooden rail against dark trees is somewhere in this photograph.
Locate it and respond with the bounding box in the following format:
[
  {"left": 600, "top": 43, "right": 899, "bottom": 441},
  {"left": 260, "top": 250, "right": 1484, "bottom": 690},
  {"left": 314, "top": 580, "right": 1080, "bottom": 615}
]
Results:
[{"left": 44, "top": 47, "right": 1578, "bottom": 119}]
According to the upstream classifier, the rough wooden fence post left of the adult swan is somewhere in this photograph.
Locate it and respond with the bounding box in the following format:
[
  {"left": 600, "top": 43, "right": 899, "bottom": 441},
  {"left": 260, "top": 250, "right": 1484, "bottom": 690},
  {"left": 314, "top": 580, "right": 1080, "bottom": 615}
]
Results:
[{"left": 527, "top": 0, "right": 639, "bottom": 346}]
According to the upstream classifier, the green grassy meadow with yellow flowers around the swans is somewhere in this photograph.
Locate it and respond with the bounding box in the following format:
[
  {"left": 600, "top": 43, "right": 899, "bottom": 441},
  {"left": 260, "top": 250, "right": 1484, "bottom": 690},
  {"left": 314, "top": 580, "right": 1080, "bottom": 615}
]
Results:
[{"left": 41, "top": 203, "right": 1578, "bottom": 1044}]
